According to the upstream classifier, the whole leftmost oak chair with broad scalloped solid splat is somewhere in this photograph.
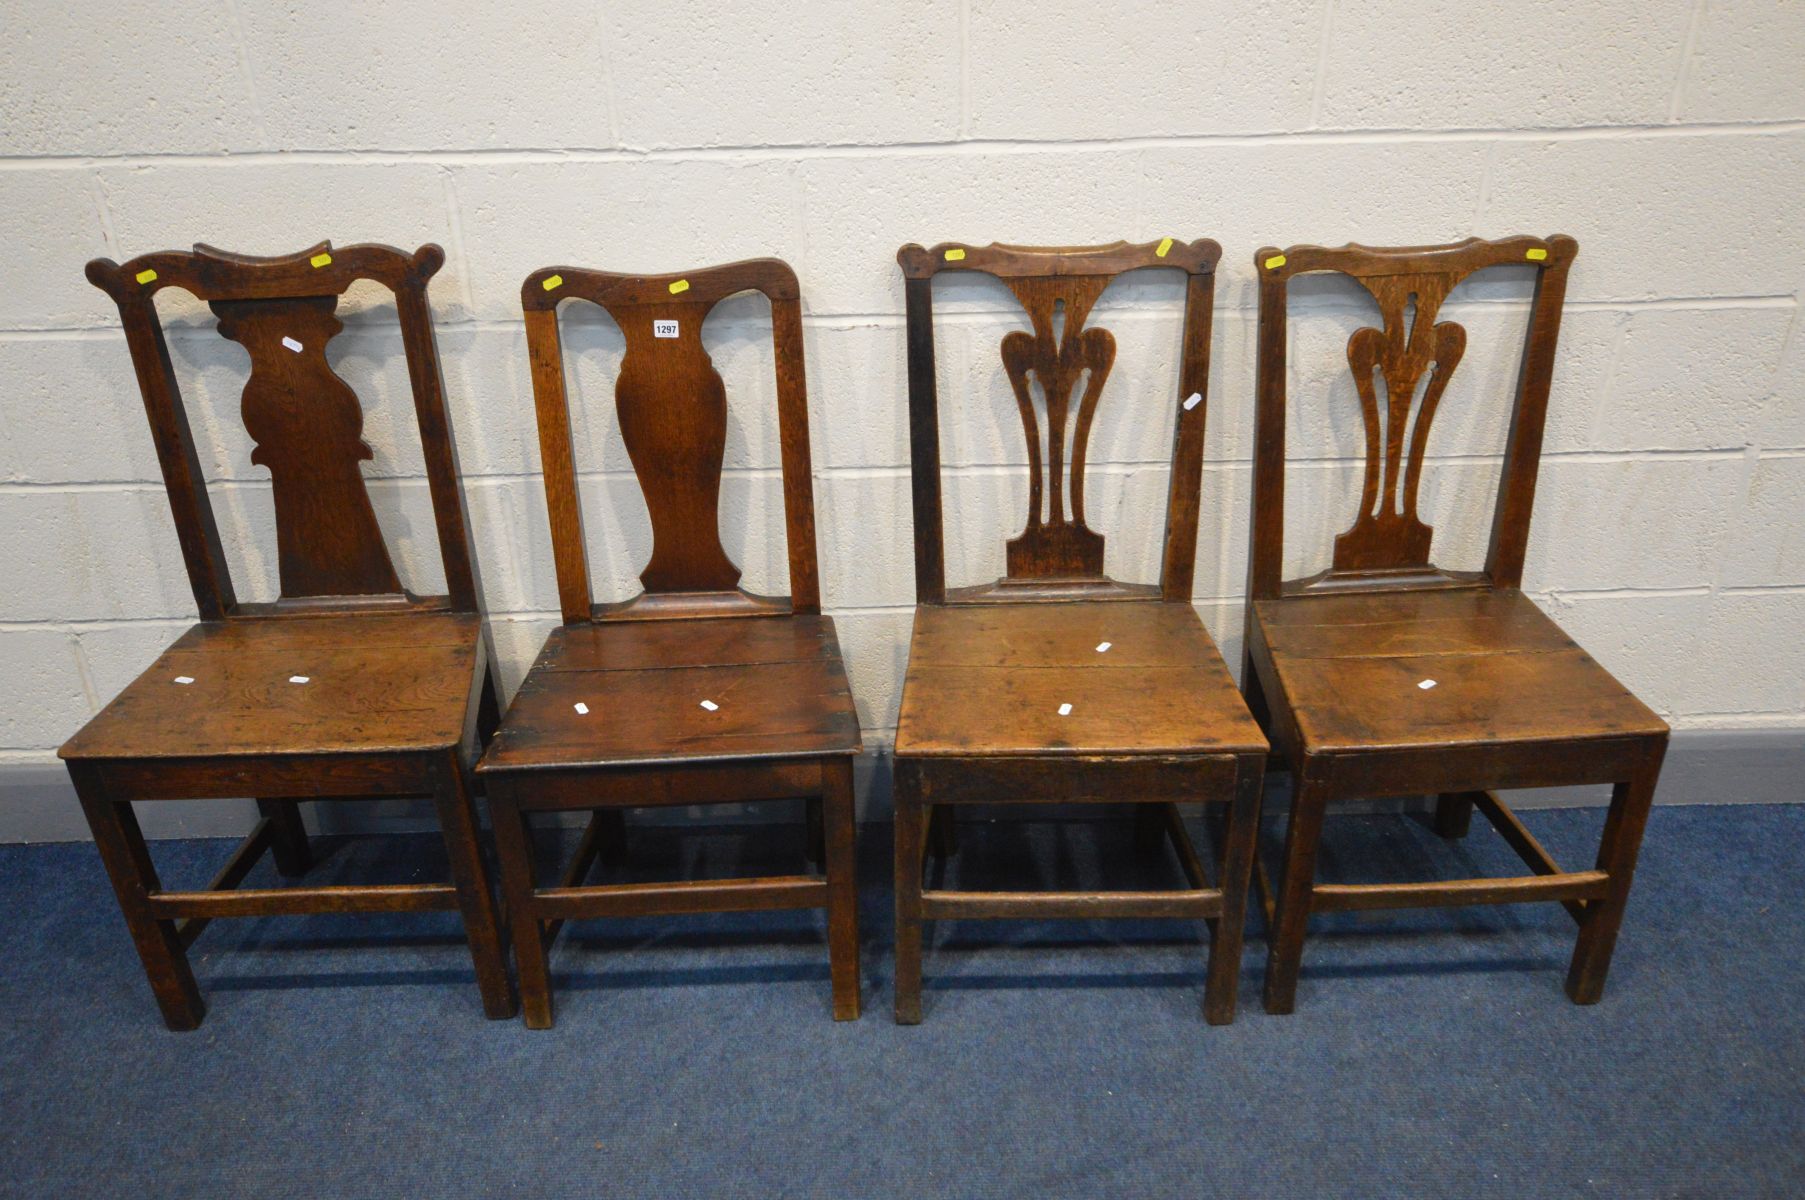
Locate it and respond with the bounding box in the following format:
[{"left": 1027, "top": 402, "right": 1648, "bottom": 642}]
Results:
[{"left": 58, "top": 242, "right": 514, "bottom": 1029}]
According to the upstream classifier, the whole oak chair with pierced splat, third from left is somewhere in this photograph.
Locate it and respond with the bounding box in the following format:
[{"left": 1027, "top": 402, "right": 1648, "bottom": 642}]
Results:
[{"left": 895, "top": 238, "right": 1267, "bottom": 1025}]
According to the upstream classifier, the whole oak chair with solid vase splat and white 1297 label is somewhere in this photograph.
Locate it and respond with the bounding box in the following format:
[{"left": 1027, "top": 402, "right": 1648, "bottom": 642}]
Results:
[{"left": 478, "top": 258, "right": 861, "bottom": 1029}]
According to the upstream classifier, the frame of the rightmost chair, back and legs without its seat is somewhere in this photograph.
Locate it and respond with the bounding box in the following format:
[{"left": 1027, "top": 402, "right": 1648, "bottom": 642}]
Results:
[{"left": 1242, "top": 235, "right": 1666, "bottom": 1012}]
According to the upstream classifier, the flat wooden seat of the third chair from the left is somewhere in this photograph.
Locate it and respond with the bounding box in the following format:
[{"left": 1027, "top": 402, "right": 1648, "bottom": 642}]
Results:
[{"left": 897, "top": 601, "right": 1265, "bottom": 756}]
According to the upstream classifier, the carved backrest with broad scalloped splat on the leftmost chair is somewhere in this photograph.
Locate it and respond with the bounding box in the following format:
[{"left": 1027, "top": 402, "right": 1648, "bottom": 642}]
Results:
[{"left": 87, "top": 242, "right": 477, "bottom": 621}]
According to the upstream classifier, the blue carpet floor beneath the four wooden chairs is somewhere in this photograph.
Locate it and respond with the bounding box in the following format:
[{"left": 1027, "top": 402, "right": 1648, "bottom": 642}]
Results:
[{"left": 0, "top": 805, "right": 1805, "bottom": 1198}]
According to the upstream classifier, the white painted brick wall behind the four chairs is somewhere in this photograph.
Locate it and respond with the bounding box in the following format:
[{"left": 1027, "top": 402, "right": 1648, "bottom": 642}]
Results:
[{"left": 0, "top": 0, "right": 1805, "bottom": 804}]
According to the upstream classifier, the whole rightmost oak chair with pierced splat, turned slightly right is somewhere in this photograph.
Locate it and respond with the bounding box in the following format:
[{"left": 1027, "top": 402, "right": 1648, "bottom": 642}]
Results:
[{"left": 1244, "top": 236, "right": 1668, "bottom": 1012}]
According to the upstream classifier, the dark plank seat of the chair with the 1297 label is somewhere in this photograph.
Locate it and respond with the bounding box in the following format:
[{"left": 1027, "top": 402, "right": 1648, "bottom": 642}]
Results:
[{"left": 484, "top": 614, "right": 859, "bottom": 771}]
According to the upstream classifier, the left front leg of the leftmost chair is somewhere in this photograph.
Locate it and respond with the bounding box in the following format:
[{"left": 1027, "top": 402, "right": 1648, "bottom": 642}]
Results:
[{"left": 69, "top": 763, "right": 208, "bottom": 1030}]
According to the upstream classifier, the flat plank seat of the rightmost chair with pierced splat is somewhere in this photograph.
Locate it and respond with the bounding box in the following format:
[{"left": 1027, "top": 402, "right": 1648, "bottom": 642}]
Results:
[{"left": 1253, "top": 588, "right": 1666, "bottom": 754}]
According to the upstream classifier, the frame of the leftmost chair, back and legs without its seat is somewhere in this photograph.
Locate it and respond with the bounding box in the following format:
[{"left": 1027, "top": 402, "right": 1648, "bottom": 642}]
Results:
[{"left": 61, "top": 242, "right": 516, "bottom": 1030}]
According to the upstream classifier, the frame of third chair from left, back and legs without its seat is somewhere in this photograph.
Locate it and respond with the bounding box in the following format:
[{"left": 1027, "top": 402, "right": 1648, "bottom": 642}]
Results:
[{"left": 895, "top": 238, "right": 1267, "bottom": 1025}]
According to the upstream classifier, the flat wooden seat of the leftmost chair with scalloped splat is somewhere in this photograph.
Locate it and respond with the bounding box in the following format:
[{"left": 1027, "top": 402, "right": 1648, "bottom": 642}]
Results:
[{"left": 61, "top": 612, "right": 482, "bottom": 760}]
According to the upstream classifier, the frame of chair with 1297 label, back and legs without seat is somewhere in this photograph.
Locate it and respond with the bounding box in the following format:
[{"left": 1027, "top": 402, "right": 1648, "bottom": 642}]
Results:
[{"left": 478, "top": 258, "right": 861, "bottom": 1029}]
